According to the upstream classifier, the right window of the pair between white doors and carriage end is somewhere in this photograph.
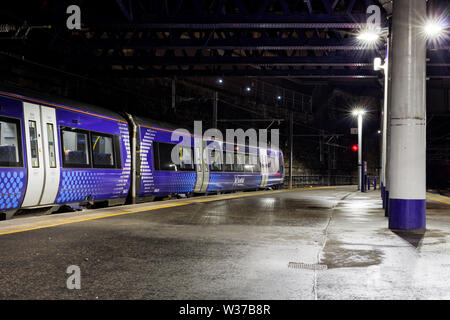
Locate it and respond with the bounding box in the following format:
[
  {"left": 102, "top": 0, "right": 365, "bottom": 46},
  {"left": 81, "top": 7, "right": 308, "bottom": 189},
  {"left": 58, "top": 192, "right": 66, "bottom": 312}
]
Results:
[{"left": 91, "top": 132, "right": 114, "bottom": 168}]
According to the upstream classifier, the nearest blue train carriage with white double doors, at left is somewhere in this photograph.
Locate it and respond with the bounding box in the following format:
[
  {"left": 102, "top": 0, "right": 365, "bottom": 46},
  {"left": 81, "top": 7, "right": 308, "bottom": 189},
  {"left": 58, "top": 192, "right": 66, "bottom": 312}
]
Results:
[{"left": 0, "top": 91, "right": 131, "bottom": 218}]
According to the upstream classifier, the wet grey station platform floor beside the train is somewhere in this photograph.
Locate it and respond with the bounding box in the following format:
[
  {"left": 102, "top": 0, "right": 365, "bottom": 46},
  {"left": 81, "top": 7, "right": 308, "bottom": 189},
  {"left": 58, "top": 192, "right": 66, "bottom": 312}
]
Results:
[{"left": 0, "top": 186, "right": 450, "bottom": 300}]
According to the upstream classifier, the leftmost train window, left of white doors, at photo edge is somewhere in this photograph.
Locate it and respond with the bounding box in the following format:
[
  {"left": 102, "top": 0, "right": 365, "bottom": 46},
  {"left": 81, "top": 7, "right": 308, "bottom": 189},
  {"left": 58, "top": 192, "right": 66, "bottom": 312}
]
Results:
[{"left": 0, "top": 117, "right": 23, "bottom": 167}]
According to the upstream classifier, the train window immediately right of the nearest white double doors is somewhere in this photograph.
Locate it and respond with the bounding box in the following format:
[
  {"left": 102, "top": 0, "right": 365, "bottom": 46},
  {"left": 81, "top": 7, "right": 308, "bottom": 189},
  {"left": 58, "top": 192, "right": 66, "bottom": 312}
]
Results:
[{"left": 61, "top": 128, "right": 90, "bottom": 168}]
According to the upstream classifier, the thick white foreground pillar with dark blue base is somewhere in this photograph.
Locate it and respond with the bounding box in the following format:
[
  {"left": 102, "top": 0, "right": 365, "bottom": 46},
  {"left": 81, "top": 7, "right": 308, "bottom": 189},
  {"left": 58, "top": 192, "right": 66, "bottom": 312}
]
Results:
[{"left": 389, "top": 0, "right": 427, "bottom": 229}]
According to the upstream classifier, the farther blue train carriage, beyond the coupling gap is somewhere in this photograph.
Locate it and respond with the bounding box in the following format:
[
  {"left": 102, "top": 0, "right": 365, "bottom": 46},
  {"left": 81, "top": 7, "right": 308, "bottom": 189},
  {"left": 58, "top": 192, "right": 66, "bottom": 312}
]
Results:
[{"left": 134, "top": 117, "right": 284, "bottom": 202}]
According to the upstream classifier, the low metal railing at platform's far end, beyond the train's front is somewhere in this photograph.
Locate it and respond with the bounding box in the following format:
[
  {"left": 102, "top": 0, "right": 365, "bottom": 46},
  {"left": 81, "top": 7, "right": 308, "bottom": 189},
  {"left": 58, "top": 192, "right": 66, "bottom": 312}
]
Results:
[{"left": 284, "top": 175, "right": 358, "bottom": 187}]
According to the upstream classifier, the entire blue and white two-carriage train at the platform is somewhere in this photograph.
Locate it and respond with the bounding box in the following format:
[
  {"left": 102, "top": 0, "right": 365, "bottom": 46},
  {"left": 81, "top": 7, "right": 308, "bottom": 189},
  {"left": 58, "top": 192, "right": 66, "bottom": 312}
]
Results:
[{"left": 0, "top": 88, "right": 284, "bottom": 220}]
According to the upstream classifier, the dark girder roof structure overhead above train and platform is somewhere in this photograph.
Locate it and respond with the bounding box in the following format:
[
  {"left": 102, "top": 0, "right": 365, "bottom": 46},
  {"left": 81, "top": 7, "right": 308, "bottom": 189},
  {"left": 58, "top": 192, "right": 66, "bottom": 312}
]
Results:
[{"left": 0, "top": 0, "right": 450, "bottom": 85}]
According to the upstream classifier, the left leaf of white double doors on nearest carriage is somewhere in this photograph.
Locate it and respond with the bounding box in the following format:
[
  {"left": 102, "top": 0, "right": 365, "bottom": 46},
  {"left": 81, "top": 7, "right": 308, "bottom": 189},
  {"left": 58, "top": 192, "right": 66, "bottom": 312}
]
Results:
[{"left": 22, "top": 102, "right": 45, "bottom": 207}]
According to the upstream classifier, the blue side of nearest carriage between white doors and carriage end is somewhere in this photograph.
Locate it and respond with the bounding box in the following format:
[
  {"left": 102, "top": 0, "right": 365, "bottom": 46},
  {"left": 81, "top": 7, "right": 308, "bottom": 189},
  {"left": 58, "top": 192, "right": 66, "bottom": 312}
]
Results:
[{"left": 56, "top": 108, "right": 131, "bottom": 204}]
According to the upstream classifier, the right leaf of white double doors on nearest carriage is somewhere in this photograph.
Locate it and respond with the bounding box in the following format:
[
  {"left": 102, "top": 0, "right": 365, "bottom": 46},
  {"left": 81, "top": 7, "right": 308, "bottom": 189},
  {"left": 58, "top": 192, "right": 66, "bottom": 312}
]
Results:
[{"left": 39, "top": 106, "right": 60, "bottom": 205}]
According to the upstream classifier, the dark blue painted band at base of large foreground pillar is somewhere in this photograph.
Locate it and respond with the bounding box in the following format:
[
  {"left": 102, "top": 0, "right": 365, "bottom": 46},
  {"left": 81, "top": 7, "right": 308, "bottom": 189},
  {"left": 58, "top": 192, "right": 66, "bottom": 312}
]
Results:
[{"left": 389, "top": 199, "right": 426, "bottom": 230}]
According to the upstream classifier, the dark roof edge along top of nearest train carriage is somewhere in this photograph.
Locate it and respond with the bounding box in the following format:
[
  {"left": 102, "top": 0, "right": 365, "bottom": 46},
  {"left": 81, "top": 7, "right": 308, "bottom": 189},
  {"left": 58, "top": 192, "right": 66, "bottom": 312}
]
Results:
[{"left": 0, "top": 83, "right": 126, "bottom": 121}]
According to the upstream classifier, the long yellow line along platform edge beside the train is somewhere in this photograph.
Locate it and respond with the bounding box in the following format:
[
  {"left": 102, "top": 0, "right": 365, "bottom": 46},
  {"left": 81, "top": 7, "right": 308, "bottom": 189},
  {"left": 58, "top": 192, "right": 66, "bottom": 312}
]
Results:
[{"left": 0, "top": 187, "right": 337, "bottom": 236}]
